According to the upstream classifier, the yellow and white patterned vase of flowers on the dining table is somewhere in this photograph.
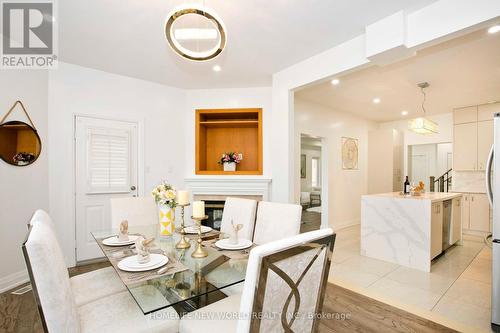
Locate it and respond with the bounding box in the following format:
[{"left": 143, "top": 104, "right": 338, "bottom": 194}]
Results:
[{"left": 151, "top": 182, "right": 177, "bottom": 237}]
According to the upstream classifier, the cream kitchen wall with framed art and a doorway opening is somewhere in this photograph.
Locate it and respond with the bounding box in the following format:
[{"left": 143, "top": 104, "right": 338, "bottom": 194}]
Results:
[{"left": 294, "top": 99, "right": 376, "bottom": 229}]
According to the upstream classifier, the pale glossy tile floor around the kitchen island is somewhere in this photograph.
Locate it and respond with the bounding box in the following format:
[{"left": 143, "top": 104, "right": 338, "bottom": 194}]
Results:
[{"left": 329, "top": 225, "right": 491, "bottom": 332}]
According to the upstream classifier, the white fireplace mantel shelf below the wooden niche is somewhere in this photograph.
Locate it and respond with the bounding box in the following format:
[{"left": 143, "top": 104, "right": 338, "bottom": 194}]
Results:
[{"left": 184, "top": 176, "right": 272, "bottom": 201}]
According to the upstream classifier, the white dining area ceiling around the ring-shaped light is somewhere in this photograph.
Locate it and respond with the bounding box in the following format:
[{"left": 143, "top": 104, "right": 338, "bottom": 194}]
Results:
[{"left": 58, "top": 0, "right": 436, "bottom": 88}]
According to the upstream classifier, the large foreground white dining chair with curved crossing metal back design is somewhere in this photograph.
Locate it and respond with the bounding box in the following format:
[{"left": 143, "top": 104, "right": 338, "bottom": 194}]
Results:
[{"left": 179, "top": 228, "right": 335, "bottom": 333}]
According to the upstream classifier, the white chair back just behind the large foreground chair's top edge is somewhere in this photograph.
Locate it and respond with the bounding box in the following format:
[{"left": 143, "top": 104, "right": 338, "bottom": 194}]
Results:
[{"left": 253, "top": 201, "right": 302, "bottom": 245}]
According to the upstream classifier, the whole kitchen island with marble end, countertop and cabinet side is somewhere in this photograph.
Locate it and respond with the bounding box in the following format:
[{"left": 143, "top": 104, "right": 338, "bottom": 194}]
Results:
[{"left": 361, "top": 192, "right": 462, "bottom": 272}]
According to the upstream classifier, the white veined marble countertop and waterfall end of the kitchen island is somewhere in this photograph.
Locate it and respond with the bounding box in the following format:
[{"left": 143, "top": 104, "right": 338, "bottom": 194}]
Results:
[{"left": 361, "top": 192, "right": 461, "bottom": 272}]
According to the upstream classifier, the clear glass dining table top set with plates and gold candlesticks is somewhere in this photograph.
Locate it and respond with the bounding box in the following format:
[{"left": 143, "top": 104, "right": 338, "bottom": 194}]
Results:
[{"left": 92, "top": 224, "right": 248, "bottom": 315}]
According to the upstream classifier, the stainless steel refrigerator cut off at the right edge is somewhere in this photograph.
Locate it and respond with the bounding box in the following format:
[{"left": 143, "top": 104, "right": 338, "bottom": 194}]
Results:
[{"left": 486, "top": 113, "right": 500, "bottom": 332}]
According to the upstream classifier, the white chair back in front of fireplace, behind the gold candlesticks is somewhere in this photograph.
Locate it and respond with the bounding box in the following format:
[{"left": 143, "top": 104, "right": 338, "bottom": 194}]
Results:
[{"left": 220, "top": 198, "right": 257, "bottom": 240}]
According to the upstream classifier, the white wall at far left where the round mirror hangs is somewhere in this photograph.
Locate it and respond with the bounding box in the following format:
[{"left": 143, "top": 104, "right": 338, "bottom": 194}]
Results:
[{"left": 0, "top": 70, "right": 49, "bottom": 292}]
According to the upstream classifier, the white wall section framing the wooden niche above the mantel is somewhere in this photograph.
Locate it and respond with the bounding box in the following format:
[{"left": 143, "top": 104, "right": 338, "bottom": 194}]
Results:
[{"left": 184, "top": 87, "right": 272, "bottom": 177}]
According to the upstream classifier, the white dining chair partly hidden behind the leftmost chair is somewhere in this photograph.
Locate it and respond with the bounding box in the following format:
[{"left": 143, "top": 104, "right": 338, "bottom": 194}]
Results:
[{"left": 29, "top": 210, "right": 127, "bottom": 306}]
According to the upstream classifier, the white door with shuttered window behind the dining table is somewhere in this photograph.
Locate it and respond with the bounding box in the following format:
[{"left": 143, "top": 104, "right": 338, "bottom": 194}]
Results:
[{"left": 75, "top": 116, "right": 139, "bottom": 261}]
